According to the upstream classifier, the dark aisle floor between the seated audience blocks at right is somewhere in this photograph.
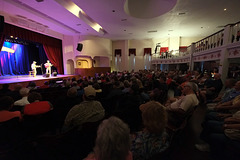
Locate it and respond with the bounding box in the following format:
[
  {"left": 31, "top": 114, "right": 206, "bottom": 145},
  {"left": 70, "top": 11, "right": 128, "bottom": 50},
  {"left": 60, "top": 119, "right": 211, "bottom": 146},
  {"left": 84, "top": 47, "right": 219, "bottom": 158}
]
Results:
[{"left": 169, "top": 106, "right": 210, "bottom": 160}]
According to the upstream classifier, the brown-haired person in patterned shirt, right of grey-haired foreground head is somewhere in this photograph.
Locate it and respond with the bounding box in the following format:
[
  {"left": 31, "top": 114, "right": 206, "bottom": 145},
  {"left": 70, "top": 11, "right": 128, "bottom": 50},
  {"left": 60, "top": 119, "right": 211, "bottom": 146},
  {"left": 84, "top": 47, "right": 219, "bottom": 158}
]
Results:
[{"left": 131, "top": 101, "right": 169, "bottom": 160}]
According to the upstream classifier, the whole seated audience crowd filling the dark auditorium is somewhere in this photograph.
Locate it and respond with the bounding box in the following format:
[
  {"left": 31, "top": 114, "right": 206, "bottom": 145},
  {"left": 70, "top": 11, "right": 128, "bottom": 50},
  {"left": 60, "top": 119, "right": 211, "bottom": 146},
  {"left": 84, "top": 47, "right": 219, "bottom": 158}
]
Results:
[{"left": 0, "top": 70, "right": 240, "bottom": 160}]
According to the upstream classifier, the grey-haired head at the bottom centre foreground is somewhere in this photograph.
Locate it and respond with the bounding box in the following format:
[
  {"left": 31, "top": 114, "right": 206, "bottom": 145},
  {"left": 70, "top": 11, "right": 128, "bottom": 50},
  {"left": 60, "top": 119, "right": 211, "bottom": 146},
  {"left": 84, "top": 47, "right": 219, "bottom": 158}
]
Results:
[{"left": 94, "top": 117, "right": 132, "bottom": 160}]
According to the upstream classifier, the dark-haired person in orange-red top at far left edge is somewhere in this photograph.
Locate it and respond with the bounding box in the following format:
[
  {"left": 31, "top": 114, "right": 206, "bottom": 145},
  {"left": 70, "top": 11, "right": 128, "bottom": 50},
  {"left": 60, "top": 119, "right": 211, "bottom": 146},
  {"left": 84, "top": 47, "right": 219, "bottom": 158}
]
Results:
[{"left": 0, "top": 96, "right": 22, "bottom": 122}]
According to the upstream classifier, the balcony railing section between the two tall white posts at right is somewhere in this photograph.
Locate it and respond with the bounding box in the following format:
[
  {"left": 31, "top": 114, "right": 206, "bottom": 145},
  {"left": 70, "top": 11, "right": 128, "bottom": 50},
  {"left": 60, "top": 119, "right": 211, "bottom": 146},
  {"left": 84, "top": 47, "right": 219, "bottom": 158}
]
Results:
[{"left": 195, "top": 29, "right": 224, "bottom": 52}]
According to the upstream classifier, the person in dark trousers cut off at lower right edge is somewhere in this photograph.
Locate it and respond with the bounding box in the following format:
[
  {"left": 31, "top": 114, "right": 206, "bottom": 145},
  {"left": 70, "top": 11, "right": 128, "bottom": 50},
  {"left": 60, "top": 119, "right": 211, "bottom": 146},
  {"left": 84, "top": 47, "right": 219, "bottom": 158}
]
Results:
[{"left": 195, "top": 111, "right": 240, "bottom": 160}]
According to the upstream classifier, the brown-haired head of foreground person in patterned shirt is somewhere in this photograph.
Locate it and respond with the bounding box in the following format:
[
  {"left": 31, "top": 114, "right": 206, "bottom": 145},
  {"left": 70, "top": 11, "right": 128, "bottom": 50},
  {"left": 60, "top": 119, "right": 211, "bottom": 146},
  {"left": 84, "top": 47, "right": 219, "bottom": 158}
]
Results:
[{"left": 140, "top": 101, "right": 167, "bottom": 134}]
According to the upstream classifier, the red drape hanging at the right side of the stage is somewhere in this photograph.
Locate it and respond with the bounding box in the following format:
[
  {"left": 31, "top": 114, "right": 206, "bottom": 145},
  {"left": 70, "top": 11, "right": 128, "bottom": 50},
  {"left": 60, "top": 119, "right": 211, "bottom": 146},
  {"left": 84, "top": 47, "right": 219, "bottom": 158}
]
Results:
[{"left": 43, "top": 44, "right": 63, "bottom": 74}]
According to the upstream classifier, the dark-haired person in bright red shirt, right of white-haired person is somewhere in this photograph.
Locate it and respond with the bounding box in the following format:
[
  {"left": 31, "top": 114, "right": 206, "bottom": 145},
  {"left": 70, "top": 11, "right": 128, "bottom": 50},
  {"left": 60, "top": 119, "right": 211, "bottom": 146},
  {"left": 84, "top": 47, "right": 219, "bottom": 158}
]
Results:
[{"left": 23, "top": 92, "right": 53, "bottom": 115}]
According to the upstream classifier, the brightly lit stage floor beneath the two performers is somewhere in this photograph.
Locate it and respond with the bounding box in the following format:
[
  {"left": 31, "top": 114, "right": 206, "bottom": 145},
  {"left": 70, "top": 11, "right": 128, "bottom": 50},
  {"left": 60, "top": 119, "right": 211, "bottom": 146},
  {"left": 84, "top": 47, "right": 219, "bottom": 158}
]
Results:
[{"left": 0, "top": 75, "right": 79, "bottom": 89}]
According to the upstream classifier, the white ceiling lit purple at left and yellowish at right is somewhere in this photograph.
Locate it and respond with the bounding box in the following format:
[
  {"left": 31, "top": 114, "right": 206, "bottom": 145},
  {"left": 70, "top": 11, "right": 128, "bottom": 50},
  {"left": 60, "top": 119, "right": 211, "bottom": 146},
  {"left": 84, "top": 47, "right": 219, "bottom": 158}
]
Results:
[{"left": 0, "top": 0, "right": 240, "bottom": 40}]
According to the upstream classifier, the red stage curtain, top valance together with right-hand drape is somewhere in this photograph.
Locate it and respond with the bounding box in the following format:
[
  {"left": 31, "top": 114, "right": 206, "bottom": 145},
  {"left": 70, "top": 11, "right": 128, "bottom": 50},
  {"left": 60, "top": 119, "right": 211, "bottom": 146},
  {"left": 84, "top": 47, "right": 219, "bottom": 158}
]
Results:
[{"left": 0, "top": 23, "right": 63, "bottom": 74}]
